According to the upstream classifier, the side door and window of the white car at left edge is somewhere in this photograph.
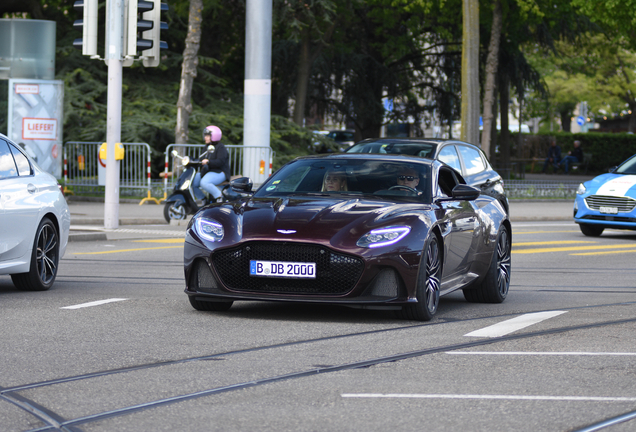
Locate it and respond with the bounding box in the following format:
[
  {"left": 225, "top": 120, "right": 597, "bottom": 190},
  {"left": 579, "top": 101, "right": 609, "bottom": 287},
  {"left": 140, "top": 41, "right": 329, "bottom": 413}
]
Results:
[{"left": 0, "top": 139, "right": 39, "bottom": 262}]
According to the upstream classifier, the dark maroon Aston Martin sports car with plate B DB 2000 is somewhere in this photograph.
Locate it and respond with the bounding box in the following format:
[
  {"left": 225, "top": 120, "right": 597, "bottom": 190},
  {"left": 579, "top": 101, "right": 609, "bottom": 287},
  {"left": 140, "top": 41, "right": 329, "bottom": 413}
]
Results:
[{"left": 184, "top": 154, "right": 512, "bottom": 320}]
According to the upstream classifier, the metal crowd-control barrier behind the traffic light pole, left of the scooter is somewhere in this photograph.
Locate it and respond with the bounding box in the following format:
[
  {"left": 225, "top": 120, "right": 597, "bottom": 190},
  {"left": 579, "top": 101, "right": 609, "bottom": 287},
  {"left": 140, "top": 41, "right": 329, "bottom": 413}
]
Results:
[{"left": 63, "top": 141, "right": 159, "bottom": 204}]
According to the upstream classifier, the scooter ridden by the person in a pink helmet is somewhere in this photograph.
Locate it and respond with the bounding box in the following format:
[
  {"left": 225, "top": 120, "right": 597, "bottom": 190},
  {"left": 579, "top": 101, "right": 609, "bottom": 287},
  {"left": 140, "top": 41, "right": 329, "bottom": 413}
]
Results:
[{"left": 163, "top": 146, "right": 240, "bottom": 223}]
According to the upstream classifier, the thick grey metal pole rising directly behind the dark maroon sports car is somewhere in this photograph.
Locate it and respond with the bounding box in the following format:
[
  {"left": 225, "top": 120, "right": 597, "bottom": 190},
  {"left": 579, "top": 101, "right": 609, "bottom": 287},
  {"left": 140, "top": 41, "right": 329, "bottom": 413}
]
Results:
[{"left": 243, "top": 0, "right": 272, "bottom": 184}]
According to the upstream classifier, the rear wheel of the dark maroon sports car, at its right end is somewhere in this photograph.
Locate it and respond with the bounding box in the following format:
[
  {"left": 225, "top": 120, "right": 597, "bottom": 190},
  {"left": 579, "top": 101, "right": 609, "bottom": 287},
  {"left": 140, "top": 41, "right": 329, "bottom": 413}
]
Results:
[{"left": 463, "top": 226, "right": 511, "bottom": 303}]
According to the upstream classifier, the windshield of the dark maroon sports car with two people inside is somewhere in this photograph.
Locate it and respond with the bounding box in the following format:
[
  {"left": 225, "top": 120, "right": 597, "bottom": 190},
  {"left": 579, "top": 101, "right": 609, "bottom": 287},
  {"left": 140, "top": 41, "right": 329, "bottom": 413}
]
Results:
[{"left": 255, "top": 159, "right": 431, "bottom": 203}]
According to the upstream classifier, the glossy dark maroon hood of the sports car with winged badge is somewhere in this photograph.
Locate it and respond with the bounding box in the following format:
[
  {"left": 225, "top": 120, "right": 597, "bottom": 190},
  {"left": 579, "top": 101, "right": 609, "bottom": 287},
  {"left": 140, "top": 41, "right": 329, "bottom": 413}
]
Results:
[{"left": 243, "top": 197, "right": 426, "bottom": 243}]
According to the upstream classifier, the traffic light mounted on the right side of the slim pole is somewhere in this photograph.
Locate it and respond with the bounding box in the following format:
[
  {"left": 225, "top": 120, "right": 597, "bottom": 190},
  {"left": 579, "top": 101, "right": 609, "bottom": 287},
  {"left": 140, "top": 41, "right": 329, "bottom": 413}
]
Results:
[{"left": 125, "top": 0, "right": 168, "bottom": 67}]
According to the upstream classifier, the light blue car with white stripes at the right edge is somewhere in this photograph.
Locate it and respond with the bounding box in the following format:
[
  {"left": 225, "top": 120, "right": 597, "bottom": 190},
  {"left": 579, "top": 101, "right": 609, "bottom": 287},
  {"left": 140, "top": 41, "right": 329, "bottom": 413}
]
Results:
[{"left": 574, "top": 155, "right": 636, "bottom": 237}]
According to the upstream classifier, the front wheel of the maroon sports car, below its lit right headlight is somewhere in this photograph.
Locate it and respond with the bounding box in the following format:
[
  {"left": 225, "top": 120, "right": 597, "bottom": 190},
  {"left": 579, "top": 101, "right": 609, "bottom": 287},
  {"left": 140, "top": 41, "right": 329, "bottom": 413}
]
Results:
[{"left": 397, "top": 234, "right": 442, "bottom": 321}]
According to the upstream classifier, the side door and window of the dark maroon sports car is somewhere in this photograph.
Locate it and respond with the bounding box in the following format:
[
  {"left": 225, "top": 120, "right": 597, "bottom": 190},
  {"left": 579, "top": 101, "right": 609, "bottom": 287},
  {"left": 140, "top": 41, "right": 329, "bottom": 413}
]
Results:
[{"left": 437, "top": 167, "right": 478, "bottom": 289}]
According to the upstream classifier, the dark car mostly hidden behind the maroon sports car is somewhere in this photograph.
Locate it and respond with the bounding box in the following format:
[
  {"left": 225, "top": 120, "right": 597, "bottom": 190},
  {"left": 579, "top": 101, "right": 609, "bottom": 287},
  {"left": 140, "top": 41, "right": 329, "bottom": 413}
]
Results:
[{"left": 346, "top": 138, "right": 509, "bottom": 213}]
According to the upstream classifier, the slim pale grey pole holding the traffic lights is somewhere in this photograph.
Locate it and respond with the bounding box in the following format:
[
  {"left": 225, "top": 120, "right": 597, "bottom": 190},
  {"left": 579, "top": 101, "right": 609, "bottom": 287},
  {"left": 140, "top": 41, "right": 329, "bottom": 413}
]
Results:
[{"left": 104, "top": 0, "right": 125, "bottom": 229}]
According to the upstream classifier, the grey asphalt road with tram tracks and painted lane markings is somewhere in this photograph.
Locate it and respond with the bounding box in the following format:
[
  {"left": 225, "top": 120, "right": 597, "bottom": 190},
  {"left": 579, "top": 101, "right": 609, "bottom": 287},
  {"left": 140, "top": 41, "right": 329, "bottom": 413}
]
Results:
[{"left": 0, "top": 221, "right": 636, "bottom": 432}]
